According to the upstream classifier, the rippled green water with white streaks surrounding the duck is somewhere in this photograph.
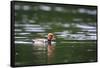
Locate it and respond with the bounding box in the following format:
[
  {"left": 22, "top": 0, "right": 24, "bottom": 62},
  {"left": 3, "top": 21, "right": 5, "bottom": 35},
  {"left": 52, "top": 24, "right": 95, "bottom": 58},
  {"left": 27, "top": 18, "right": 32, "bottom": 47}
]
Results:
[{"left": 14, "top": 2, "right": 97, "bottom": 66}]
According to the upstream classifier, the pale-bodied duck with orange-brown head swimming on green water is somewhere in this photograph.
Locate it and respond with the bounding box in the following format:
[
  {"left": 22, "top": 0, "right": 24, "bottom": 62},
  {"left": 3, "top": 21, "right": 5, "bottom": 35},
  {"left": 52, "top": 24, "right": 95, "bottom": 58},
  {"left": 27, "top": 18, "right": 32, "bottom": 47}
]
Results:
[{"left": 32, "top": 33, "right": 55, "bottom": 46}]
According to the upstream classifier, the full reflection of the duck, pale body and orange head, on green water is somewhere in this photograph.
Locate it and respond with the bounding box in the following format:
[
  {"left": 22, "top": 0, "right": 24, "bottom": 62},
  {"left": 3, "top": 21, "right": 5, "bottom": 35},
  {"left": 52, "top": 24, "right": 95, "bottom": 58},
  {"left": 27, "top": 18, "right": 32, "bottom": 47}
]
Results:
[{"left": 30, "top": 44, "right": 55, "bottom": 65}]
